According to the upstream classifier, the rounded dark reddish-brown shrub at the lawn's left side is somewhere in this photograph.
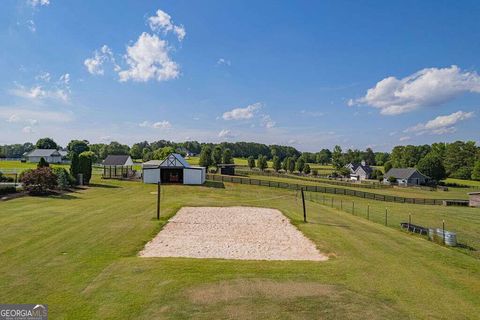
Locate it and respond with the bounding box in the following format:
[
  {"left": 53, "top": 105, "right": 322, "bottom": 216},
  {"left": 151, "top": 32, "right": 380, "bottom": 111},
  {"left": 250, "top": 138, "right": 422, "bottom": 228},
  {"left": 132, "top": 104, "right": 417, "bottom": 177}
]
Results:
[{"left": 21, "top": 167, "right": 57, "bottom": 195}]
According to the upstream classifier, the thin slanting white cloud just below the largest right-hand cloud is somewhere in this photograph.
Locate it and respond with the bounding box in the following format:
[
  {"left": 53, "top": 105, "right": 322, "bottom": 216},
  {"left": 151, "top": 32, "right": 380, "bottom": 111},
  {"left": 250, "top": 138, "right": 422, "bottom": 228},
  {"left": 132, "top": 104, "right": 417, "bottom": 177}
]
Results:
[{"left": 404, "top": 111, "right": 474, "bottom": 135}]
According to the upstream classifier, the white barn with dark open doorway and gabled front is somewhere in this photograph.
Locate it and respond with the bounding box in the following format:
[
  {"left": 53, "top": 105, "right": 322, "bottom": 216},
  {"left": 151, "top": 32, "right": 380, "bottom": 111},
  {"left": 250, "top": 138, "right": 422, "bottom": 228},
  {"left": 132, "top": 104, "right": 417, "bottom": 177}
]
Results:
[{"left": 142, "top": 153, "right": 206, "bottom": 184}]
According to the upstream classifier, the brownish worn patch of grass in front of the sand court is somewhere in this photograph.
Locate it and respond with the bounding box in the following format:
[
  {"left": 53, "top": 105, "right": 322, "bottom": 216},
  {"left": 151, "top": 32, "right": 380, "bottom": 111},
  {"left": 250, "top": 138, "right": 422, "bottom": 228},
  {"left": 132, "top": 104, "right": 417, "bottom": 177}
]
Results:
[{"left": 186, "top": 279, "right": 336, "bottom": 304}]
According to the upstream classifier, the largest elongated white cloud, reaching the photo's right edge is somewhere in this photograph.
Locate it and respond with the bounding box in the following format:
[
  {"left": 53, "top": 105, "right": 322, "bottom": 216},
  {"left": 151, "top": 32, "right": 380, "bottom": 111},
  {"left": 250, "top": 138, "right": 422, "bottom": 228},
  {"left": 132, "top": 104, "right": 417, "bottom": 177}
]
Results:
[{"left": 348, "top": 66, "right": 480, "bottom": 115}]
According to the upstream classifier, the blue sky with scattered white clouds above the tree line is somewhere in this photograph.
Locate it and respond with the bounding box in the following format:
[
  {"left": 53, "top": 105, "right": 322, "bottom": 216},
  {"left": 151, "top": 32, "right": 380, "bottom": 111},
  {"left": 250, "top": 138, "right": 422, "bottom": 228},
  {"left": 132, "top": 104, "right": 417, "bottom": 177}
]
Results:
[{"left": 0, "top": 0, "right": 480, "bottom": 151}]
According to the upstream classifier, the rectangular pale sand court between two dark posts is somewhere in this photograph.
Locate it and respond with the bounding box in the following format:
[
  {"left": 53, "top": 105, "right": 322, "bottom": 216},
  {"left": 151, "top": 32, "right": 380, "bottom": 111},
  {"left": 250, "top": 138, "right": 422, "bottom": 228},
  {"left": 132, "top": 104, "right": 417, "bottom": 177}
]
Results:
[{"left": 140, "top": 207, "right": 328, "bottom": 261}]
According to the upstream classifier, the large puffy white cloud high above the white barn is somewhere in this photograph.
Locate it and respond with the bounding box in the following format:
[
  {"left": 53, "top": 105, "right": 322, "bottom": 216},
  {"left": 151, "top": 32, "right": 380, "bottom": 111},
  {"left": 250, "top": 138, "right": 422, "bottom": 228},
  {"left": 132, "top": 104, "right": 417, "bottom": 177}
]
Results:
[{"left": 118, "top": 32, "right": 180, "bottom": 82}]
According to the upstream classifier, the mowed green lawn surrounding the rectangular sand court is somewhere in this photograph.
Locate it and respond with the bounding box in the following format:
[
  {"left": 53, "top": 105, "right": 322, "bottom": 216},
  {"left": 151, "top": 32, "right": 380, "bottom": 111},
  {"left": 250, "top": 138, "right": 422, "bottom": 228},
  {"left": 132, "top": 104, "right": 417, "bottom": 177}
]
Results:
[{"left": 0, "top": 177, "right": 480, "bottom": 319}]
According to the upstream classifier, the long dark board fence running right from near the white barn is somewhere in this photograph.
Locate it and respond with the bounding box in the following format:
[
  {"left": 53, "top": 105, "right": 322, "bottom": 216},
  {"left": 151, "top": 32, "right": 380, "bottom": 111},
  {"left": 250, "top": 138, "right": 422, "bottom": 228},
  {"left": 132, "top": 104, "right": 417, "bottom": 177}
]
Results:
[{"left": 207, "top": 173, "right": 467, "bottom": 205}]
